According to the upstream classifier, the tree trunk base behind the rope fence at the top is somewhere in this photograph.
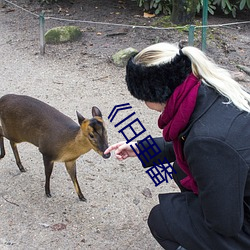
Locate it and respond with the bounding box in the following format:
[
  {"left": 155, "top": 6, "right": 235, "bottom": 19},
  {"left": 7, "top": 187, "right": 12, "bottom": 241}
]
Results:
[{"left": 171, "top": 0, "right": 198, "bottom": 25}]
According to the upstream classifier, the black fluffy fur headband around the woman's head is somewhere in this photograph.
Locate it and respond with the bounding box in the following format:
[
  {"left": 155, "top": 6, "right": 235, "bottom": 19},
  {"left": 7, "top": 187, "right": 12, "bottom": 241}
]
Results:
[{"left": 126, "top": 50, "right": 192, "bottom": 103}]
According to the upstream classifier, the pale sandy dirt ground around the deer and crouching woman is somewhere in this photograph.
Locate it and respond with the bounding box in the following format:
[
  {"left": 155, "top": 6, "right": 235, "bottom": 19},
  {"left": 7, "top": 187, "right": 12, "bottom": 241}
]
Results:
[{"left": 0, "top": 1, "right": 250, "bottom": 250}]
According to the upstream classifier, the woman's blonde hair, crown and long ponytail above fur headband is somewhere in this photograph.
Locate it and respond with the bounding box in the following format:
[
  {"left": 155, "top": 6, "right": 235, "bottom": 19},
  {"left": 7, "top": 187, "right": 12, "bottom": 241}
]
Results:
[{"left": 134, "top": 43, "right": 250, "bottom": 113}]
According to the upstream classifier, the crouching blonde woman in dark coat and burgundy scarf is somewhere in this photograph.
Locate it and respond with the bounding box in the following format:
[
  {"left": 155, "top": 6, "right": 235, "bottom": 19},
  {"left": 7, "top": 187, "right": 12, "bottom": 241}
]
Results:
[{"left": 105, "top": 43, "right": 250, "bottom": 250}]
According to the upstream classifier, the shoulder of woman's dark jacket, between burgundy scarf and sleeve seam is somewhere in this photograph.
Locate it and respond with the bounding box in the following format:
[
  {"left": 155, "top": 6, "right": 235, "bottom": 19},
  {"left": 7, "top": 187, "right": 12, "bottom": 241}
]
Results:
[{"left": 185, "top": 86, "right": 250, "bottom": 148}]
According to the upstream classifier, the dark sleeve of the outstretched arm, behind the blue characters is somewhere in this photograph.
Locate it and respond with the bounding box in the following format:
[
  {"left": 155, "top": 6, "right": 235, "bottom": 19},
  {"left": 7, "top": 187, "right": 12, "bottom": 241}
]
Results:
[{"left": 137, "top": 137, "right": 175, "bottom": 168}]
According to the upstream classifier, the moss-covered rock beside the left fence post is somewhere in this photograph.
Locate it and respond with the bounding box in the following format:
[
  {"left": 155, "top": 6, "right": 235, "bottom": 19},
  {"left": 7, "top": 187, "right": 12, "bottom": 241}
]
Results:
[{"left": 45, "top": 26, "right": 82, "bottom": 44}]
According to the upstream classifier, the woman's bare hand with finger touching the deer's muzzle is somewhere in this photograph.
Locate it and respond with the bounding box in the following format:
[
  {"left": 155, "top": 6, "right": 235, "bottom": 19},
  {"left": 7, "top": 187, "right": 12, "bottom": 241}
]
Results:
[{"left": 104, "top": 141, "right": 139, "bottom": 161}]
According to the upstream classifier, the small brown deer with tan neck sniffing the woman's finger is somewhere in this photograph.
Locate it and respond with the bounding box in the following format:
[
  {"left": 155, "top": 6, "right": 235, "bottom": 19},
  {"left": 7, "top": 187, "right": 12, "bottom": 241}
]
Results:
[{"left": 0, "top": 94, "right": 110, "bottom": 201}]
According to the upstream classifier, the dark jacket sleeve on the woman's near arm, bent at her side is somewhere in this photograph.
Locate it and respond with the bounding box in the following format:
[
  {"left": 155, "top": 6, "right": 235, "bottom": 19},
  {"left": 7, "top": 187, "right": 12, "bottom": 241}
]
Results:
[{"left": 184, "top": 137, "right": 248, "bottom": 237}]
